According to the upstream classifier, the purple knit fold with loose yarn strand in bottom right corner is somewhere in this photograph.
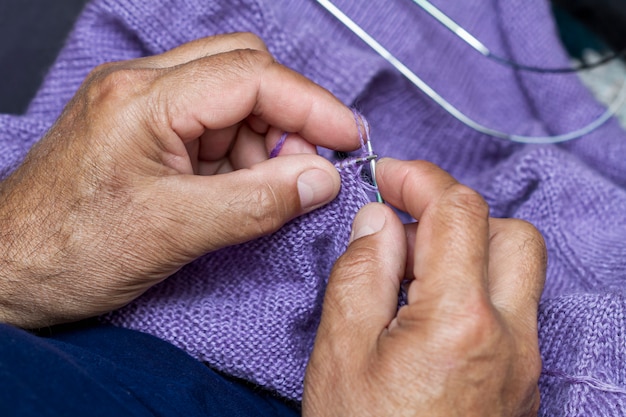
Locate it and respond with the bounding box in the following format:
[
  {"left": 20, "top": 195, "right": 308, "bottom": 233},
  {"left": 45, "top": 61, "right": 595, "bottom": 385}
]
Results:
[{"left": 539, "top": 292, "right": 626, "bottom": 416}]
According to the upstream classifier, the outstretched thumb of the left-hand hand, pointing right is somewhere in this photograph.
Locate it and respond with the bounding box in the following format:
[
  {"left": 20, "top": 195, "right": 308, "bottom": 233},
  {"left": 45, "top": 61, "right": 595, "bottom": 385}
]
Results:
[{"left": 148, "top": 155, "right": 341, "bottom": 254}]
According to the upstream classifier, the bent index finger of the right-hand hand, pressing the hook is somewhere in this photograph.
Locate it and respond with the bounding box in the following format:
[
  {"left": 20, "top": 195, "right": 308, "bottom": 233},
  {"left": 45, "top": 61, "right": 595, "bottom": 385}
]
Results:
[{"left": 377, "top": 160, "right": 489, "bottom": 303}]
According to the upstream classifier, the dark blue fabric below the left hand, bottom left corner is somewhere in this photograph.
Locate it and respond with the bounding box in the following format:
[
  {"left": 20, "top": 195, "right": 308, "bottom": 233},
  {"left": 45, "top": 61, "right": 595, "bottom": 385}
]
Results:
[{"left": 0, "top": 324, "right": 299, "bottom": 417}]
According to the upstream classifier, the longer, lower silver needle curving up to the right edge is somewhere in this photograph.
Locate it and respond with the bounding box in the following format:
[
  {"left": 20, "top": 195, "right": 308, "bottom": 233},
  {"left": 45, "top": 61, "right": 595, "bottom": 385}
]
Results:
[{"left": 316, "top": 0, "right": 626, "bottom": 144}]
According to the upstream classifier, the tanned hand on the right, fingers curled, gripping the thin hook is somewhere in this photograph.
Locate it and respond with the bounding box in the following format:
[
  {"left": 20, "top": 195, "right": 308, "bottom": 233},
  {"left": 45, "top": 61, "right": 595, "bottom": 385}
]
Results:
[{"left": 303, "top": 160, "right": 546, "bottom": 417}]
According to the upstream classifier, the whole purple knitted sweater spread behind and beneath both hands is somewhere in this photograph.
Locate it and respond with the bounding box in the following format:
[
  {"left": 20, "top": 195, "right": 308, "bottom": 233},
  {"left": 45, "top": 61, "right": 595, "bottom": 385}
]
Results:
[{"left": 0, "top": 0, "right": 626, "bottom": 416}]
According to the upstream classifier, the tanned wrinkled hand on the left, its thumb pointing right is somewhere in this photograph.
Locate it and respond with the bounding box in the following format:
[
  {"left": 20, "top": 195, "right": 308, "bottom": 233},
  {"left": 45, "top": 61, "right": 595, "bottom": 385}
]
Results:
[{"left": 0, "top": 34, "right": 358, "bottom": 327}]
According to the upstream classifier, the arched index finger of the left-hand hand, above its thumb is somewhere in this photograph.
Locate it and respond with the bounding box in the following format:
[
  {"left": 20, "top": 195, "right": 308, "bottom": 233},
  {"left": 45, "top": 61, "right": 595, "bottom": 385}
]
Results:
[{"left": 149, "top": 50, "right": 359, "bottom": 150}]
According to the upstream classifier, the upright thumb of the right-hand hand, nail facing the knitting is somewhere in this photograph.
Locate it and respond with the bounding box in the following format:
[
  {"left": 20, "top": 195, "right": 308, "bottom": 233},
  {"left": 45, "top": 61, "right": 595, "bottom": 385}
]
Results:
[{"left": 316, "top": 203, "right": 407, "bottom": 353}]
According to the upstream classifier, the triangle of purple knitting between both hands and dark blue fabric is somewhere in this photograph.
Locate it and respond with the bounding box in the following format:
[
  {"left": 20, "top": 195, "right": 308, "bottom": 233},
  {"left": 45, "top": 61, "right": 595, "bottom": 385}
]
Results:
[{"left": 103, "top": 162, "right": 368, "bottom": 399}]
